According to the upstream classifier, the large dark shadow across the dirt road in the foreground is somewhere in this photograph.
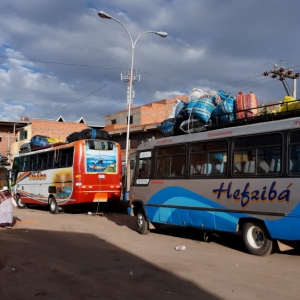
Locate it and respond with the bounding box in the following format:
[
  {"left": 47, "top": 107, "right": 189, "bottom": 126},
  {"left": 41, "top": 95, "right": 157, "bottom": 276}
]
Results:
[{"left": 0, "top": 229, "right": 219, "bottom": 300}]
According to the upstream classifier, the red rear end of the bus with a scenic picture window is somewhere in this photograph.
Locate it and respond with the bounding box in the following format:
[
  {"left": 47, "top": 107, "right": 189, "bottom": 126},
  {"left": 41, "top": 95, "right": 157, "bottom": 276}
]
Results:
[{"left": 74, "top": 140, "right": 122, "bottom": 202}]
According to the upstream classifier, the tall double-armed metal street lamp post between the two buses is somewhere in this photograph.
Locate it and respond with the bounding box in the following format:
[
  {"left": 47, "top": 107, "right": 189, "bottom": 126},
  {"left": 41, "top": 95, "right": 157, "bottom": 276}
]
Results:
[{"left": 98, "top": 11, "right": 168, "bottom": 192}]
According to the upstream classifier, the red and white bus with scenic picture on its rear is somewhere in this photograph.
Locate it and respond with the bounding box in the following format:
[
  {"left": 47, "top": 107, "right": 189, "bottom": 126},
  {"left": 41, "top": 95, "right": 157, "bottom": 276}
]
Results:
[{"left": 12, "top": 139, "right": 122, "bottom": 214}]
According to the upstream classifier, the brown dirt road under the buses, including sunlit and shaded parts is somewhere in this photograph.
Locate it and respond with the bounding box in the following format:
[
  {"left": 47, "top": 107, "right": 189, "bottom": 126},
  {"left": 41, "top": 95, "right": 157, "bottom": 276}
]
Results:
[{"left": 0, "top": 204, "right": 300, "bottom": 300}]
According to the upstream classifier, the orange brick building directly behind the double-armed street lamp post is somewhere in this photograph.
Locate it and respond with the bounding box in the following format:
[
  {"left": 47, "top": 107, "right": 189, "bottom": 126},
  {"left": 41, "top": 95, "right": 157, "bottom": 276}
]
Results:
[{"left": 104, "top": 95, "right": 187, "bottom": 158}]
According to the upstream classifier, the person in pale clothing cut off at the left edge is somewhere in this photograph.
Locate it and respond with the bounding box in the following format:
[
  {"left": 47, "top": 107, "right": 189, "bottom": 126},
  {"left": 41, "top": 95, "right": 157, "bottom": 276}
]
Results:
[{"left": 0, "top": 186, "right": 13, "bottom": 229}]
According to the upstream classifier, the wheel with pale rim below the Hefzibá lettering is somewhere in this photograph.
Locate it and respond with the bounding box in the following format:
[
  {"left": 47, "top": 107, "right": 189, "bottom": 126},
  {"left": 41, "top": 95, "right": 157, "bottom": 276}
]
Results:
[{"left": 243, "top": 222, "right": 274, "bottom": 256}]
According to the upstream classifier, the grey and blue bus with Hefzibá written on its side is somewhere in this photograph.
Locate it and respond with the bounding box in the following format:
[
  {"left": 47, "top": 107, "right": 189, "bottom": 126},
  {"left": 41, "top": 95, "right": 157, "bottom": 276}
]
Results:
[{"left": 129, "top": 112, "right": 300, "bottom": 256}]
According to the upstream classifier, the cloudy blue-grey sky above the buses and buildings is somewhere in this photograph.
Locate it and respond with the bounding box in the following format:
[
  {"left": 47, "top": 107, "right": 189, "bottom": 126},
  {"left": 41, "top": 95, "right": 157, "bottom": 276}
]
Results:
[{"left": 0, "top": 0, "right": 300, "bottom": 124}]
